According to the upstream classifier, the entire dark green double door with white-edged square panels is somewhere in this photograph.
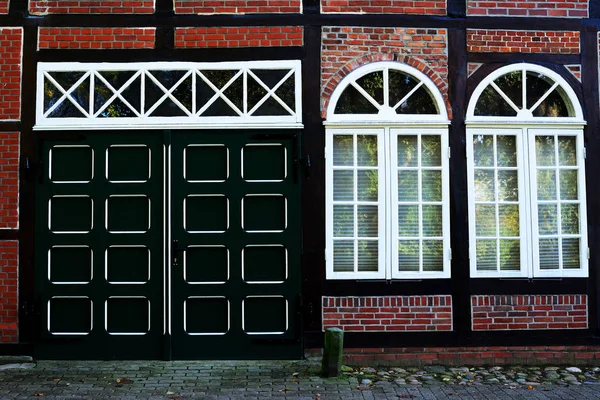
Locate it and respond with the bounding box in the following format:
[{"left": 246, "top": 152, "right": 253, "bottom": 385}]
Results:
[{"left": 35, "top": 132, "right": 302, "bottom": 359}]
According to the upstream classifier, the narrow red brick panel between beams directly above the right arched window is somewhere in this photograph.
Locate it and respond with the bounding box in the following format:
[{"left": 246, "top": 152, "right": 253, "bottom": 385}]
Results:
[{"left": 467, "top": 29, "right": 579, "bottom": 54}]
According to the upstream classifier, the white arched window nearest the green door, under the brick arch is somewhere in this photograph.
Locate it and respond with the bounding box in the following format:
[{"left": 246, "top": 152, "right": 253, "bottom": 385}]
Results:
[{"left": 325, "top": 62, "right": 451, "bottom": 280}]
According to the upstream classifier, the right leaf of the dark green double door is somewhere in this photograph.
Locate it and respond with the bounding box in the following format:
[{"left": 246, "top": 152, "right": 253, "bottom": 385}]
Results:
[{"left": 171, "top": 131, "right": 302, "bottom": 359}]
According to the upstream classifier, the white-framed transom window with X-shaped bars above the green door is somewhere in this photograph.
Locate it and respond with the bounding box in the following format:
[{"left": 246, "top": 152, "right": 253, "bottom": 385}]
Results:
[{"left": 36, "top": 60, "right": 302, "bottom": 129}]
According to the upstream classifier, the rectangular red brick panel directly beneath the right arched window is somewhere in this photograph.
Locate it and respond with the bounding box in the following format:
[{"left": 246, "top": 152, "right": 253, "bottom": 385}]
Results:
[{"left": 471, "top": 295, "right": 588, "bottom": 331}]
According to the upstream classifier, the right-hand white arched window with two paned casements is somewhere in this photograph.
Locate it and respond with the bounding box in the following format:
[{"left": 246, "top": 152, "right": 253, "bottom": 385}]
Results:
[{"left": 466, "top": 63, "right": 589, "bottom": 278}]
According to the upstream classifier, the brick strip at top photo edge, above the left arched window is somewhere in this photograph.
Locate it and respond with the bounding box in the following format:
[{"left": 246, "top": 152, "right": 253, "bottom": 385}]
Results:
[{"left": 321, "top": 0, "right": 446, "bottom": 15}]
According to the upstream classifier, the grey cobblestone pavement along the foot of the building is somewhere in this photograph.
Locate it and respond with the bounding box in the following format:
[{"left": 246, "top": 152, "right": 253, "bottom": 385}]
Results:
[{"left": 0, "top": 359, "right": 600, "bottom": 400}]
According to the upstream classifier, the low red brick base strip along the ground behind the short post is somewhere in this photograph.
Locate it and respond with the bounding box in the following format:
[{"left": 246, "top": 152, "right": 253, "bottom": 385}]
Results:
[{"left": 307, "top": 346, "right": 600, "bottom": 366}]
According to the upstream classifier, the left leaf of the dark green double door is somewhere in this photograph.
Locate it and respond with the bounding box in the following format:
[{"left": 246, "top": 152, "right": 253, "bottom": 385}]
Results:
[{"left": 35, "top": 132, "right": 164, "bottom": 359}]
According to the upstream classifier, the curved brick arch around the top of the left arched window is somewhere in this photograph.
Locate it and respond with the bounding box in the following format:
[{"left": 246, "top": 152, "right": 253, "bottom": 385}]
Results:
[{"left": 321, "top": 53, "right": 452, "bottom": 119}]
